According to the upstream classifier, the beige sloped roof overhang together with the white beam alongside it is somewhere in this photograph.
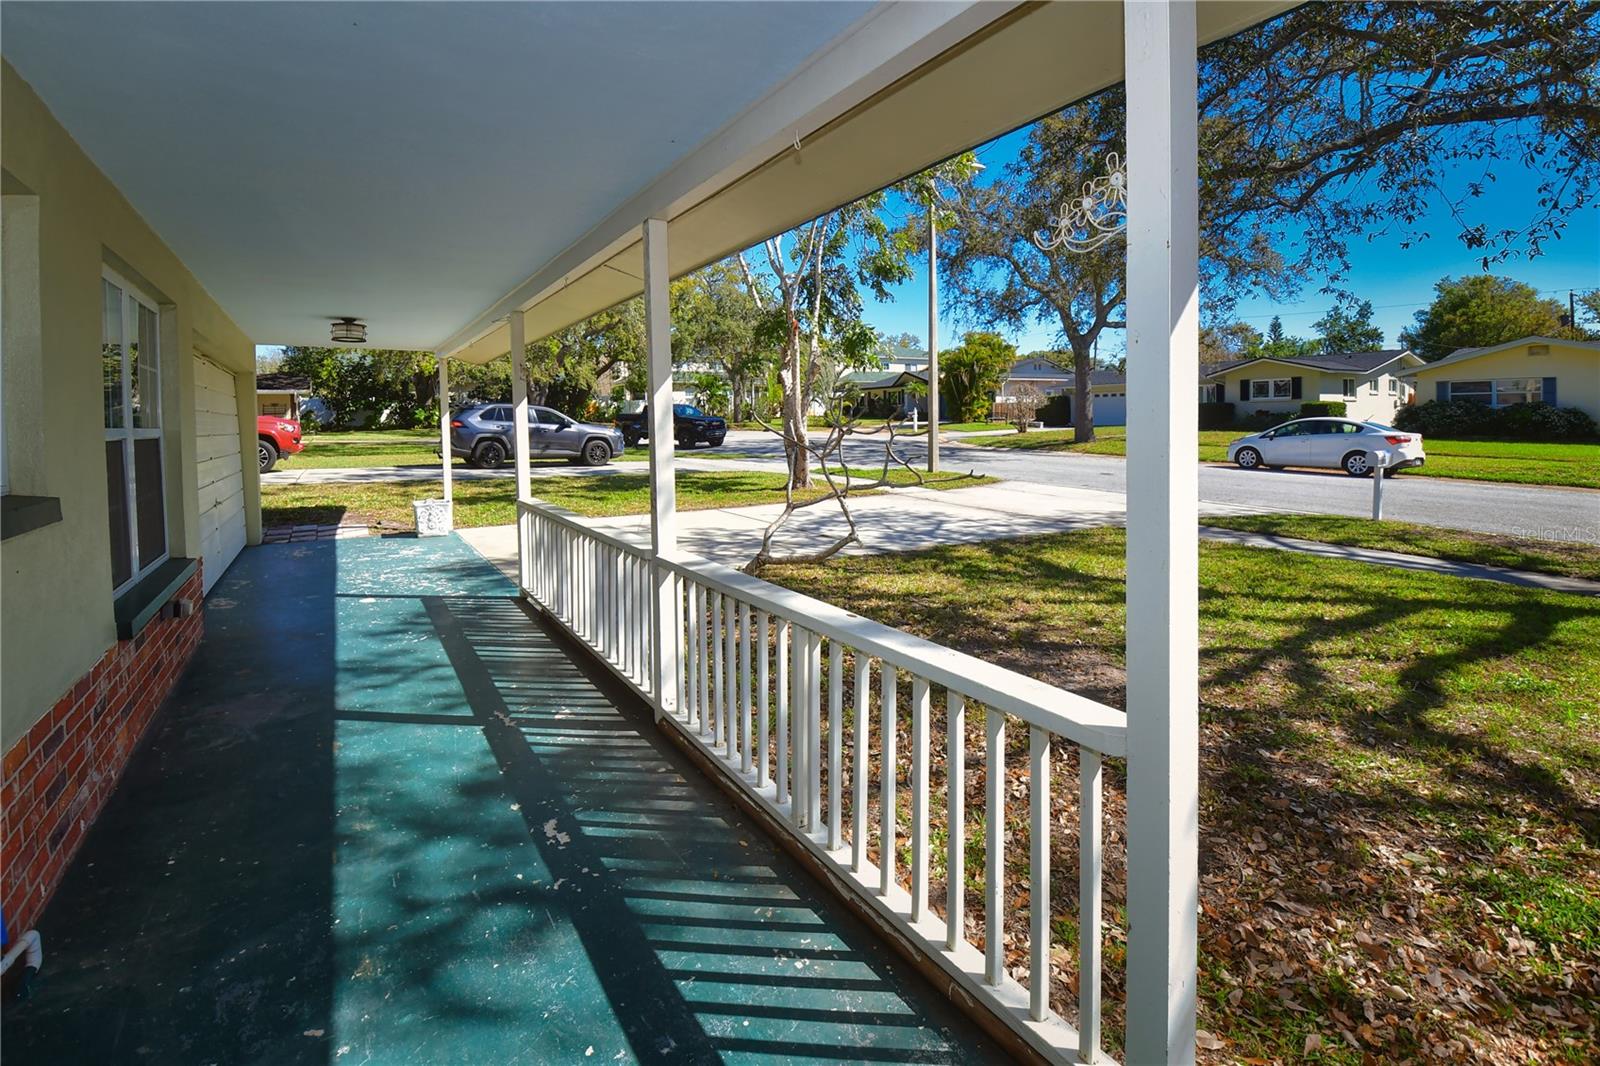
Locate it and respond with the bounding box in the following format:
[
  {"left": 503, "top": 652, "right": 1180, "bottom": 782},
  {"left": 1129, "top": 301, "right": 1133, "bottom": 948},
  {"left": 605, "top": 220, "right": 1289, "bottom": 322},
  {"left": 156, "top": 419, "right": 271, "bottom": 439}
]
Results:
[{"left": 440, "top": 0, "right": 1294, "bottom": 362}]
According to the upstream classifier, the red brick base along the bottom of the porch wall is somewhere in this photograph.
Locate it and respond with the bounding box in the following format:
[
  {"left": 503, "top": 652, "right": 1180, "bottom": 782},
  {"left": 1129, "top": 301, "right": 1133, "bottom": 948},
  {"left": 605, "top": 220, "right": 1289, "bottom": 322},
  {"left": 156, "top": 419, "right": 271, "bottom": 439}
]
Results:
[{"left": 0, "top": 568, "right": 203, "bottom": 936}]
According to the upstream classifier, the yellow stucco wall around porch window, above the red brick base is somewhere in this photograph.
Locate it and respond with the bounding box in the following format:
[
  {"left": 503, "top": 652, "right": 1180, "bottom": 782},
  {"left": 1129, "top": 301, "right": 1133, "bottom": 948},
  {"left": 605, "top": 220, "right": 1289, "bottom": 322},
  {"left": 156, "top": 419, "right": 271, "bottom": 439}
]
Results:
[{"left": 0, "top": 64, "right": 261, "bottom": 749}]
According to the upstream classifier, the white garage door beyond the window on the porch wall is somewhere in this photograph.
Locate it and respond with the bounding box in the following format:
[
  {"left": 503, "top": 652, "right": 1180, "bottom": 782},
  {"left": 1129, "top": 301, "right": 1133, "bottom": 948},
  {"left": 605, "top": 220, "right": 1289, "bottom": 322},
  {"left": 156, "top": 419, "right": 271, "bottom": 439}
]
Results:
[{"left": 195, "top": 355, "right": 245, "bottom": 592}]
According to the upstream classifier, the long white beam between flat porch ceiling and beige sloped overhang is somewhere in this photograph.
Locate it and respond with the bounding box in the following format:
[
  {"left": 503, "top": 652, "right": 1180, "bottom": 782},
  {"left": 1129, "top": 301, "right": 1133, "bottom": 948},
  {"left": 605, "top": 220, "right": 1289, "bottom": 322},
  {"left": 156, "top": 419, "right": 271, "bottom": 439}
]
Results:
[{"left": 434, "top": 0, "right": 1021, "bottom": 355}]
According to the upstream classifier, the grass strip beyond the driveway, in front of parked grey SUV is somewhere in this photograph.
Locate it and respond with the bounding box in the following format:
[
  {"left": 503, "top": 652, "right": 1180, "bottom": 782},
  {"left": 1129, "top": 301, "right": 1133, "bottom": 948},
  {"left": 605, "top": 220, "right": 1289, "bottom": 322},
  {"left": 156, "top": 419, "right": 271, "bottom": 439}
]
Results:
[{"left": 261, "top": 471, "right": 995, "bottom": 530}]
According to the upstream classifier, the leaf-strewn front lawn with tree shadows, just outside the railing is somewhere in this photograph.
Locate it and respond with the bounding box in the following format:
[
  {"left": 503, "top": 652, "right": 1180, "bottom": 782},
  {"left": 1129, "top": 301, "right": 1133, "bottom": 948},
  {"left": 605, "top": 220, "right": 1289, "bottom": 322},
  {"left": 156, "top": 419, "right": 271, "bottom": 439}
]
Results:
[{"left": 765, "top": 528, "right": 1600, "bottom": 1066}]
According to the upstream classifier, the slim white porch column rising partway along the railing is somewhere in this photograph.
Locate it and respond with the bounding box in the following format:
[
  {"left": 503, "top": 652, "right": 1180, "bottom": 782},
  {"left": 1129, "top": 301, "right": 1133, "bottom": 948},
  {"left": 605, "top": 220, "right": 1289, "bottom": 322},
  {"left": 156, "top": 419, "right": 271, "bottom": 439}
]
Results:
[{"left": 645, "top": 218, "right": 678, "bottom": 719}]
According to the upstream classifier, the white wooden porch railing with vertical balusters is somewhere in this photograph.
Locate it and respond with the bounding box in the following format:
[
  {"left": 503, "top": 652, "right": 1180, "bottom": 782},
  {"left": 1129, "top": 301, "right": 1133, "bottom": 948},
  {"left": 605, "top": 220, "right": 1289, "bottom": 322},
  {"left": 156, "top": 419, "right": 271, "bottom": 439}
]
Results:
[{"left": 517, "top": 499, "right": 1126, "bottom": 1061}]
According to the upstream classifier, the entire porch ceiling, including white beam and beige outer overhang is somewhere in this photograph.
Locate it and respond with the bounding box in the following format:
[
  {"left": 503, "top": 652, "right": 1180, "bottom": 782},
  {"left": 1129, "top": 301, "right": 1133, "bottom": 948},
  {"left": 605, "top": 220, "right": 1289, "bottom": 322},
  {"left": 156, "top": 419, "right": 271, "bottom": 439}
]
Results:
[{"left": 0, "top": 0, "right": 1293, "bottom": 362}]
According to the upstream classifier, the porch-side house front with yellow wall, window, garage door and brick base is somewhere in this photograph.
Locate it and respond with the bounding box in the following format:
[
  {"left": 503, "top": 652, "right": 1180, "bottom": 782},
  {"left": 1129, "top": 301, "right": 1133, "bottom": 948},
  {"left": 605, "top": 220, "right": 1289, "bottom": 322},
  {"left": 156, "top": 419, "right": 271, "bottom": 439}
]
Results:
[{"left": 0, "top": 64, "right": 261, "bottom": 930}]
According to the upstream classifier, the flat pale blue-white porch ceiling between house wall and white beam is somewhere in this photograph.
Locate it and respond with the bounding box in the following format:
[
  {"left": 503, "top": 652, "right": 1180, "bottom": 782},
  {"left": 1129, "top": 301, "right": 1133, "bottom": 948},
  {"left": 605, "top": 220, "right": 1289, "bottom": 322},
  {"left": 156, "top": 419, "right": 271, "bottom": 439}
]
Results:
[{"left": 0, "top": 0, "right": 876, "bottom": 347}]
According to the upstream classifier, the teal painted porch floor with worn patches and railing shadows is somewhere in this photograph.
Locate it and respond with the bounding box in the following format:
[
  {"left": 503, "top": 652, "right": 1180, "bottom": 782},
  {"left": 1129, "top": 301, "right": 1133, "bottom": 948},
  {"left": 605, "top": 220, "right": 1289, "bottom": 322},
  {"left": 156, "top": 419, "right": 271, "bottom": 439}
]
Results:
[{"left": 0, "top": 536, "right": 1002, "bottom": 1066}]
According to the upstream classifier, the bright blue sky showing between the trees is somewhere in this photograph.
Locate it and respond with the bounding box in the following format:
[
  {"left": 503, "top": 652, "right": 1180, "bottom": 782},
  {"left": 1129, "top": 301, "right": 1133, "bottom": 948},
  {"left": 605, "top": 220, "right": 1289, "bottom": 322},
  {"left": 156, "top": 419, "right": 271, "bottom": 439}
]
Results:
[{"left": 862, "top": 121, "right": 1600, "bottom": 359}]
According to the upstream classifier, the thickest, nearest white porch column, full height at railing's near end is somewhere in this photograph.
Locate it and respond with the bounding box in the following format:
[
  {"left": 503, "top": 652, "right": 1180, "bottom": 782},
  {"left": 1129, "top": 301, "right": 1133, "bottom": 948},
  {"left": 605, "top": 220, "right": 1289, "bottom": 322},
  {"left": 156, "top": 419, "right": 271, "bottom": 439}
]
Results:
[{"left": 1123, "top": 0, "right": 1200, "bottom": 1066}]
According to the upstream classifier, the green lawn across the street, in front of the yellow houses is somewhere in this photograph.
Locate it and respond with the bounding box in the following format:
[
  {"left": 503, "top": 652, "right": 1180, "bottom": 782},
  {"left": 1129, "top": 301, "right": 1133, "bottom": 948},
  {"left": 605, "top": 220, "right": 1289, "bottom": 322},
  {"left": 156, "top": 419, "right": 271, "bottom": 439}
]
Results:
[{"left": 970, "top": 426, "right": 1600, "bottom": 488}]
